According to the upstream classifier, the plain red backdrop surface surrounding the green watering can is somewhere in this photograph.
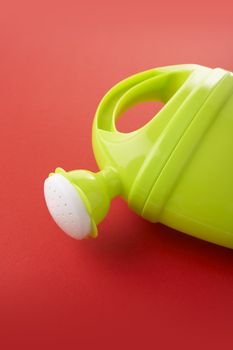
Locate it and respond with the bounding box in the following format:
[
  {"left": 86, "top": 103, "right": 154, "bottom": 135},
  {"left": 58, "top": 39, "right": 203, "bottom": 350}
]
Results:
[{"left": 0, "top": 0, "right": 233, "bottom": 350}]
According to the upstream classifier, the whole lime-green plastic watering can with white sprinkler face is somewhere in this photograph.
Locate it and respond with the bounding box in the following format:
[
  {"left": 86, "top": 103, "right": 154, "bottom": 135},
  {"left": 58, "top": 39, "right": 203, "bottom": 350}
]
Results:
[{"left": 44, "top": 65, "right": 233, "bottom": 248}]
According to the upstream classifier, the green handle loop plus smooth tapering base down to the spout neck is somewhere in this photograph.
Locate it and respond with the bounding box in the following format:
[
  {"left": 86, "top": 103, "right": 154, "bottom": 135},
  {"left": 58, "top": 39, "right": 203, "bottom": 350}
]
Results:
[{"left": 92, "top": 65, "right": 210, "bottom": 199}]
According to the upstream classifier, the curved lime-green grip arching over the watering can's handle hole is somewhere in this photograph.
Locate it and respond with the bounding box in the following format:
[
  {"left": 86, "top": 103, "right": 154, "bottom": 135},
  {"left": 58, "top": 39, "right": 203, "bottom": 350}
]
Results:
[{"left": 93, "top": 64, "right": 203, "bottom": 133}]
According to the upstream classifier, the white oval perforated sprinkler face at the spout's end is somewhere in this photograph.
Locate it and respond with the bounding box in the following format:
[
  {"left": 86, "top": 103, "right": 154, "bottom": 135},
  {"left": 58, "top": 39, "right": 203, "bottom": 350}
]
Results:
[{"left": 44, "top": 174, "right": 92, "bottom": 239}]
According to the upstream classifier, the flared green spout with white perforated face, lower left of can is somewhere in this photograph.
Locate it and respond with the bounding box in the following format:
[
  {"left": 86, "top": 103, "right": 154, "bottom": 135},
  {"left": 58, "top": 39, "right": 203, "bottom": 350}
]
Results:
[{"left": 44, "top": 167, "right": 121, "bottom": 239}]
